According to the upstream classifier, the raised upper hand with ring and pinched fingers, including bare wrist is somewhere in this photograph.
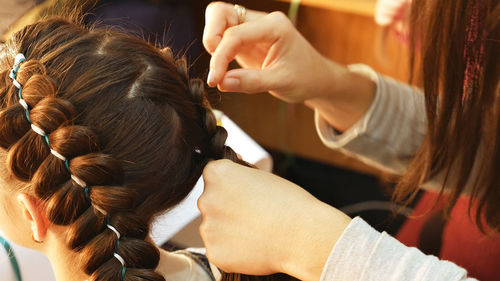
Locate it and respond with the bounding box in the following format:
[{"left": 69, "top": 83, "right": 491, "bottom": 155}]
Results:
[{"left": 203, "top": 2, "right": 375, "bottom": 131}]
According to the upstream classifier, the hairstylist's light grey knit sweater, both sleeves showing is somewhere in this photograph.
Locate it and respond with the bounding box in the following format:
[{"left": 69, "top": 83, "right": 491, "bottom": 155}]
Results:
[{"left": 316, "top": 65, "right": 476, "bottom": 281}]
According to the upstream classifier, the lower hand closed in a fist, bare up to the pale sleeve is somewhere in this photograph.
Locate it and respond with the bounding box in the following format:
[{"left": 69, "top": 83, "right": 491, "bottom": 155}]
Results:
[{"left": 198, "top": 160, "right": 350, "bottom": 281}]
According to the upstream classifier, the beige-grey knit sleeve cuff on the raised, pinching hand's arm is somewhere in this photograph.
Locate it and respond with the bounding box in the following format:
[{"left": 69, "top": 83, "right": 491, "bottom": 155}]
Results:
[{"left": 316, "top": 65, "right": 427, "bottom": 174}]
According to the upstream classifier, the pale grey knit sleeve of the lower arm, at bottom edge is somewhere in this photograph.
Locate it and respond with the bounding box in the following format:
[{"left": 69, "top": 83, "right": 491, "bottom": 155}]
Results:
[{"left": 320, "top": 217, "right": 477, "bottom": 281}]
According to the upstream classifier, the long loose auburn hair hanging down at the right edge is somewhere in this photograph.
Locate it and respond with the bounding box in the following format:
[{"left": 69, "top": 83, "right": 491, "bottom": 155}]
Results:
[{"left": 394, "top": 0, "right": 500, "bottom": 231}]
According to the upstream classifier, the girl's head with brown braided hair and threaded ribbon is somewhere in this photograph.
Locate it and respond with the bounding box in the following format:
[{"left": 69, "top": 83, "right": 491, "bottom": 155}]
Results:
[{"left": 0, "top": 14, "right": 241, "bottom": 280}]
